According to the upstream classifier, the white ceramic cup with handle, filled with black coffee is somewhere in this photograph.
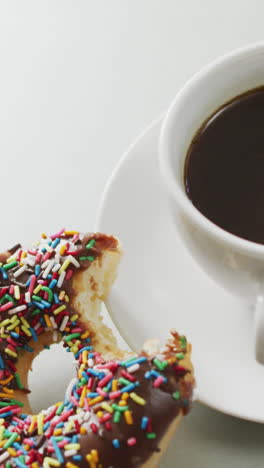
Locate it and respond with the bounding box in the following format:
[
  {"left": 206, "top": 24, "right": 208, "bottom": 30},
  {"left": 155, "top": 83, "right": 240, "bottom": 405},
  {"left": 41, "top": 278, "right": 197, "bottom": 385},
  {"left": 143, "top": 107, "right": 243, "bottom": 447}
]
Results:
[{"left": 160, "top": 43, "right": 264, "bottom": 363}]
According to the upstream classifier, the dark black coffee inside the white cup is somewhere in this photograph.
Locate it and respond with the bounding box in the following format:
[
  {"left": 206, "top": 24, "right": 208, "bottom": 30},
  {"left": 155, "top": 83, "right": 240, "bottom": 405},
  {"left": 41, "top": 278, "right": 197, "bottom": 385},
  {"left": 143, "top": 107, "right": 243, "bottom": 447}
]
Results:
[{"left": 184, "top": 87, "right": 264, "bottom": 244}]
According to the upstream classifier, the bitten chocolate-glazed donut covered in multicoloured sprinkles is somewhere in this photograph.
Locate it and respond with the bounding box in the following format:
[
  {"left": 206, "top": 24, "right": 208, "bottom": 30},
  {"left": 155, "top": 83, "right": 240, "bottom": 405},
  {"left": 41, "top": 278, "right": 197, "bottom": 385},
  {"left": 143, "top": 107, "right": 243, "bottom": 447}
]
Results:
[{"left": 0, "top": 229, "right": 194, "bottom": 468}]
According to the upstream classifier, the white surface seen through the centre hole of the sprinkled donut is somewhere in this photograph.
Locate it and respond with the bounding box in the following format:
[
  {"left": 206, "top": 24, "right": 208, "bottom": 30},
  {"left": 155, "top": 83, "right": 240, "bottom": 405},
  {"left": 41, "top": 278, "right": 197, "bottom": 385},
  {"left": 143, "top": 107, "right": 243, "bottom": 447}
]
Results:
[{"left": 28, "top": 343, "right": 76, "bottom": 413}]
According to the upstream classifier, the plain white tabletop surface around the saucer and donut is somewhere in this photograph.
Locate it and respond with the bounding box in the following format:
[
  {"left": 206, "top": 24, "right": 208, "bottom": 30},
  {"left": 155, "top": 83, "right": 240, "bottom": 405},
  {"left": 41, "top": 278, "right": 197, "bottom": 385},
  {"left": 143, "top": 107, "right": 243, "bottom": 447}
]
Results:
[{"left": 0, "top": 0, "right": 264, "bottom": 468}]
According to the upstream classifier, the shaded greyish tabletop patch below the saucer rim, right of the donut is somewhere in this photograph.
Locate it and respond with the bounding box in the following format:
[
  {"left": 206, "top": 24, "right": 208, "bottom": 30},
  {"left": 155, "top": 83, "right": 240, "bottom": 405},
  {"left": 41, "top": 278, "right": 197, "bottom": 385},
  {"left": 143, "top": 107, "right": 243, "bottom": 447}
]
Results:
[{"left": 160, "top": 402, "right": 264, "bottom": 468}]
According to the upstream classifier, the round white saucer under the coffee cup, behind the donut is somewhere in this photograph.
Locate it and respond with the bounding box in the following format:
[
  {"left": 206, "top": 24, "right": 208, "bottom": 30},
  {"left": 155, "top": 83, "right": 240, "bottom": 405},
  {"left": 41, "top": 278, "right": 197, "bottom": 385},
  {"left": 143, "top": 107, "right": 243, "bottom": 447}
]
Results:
[{"left": 97, "top": 119, "right": 264, "bottom": 422}]
